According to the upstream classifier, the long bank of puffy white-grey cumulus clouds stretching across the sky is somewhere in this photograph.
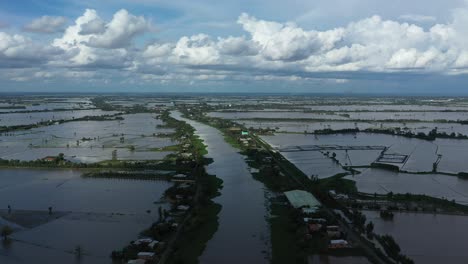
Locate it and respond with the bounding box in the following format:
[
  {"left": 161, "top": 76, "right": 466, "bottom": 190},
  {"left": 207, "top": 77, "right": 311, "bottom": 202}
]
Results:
[{"left": 4, "top": 4, "right": 468, "bottom": 86}]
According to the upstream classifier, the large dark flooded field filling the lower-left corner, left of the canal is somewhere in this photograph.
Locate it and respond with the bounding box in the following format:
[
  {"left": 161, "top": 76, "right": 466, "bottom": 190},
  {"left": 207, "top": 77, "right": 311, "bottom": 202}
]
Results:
[{"left": 0, "top": 169, "right": 171, "bottom": 264}]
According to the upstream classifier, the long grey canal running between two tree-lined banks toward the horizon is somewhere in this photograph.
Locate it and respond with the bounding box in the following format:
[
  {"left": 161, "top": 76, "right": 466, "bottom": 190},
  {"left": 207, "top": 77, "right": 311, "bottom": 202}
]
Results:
[{"left": 172, "top": 112, "right": 270, "bottom": 264}]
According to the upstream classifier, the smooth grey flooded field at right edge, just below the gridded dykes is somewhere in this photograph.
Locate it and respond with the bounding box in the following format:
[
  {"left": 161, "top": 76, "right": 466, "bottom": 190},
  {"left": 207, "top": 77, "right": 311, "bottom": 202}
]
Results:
[{"left": 346, "top": 168, "right": 468, "bottom": 204}]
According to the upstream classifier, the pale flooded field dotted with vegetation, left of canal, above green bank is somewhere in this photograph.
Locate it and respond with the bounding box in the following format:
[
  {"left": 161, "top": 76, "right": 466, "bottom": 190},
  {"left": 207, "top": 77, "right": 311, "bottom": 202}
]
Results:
[{"left": 0, "top": 114, "right": 176, "bottom": 163}]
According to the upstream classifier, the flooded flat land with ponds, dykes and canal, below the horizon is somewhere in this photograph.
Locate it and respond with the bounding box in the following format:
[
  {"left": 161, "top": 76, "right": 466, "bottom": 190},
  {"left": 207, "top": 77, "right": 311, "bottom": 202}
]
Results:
[{"left": 4, "top": 95, "right": 468, "bottom": 264}]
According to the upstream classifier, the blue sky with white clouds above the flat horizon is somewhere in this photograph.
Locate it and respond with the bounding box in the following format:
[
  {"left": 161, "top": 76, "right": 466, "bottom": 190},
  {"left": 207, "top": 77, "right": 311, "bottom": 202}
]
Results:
[{"left": 0, "top": 0, "right": 468, "bottom": 96}]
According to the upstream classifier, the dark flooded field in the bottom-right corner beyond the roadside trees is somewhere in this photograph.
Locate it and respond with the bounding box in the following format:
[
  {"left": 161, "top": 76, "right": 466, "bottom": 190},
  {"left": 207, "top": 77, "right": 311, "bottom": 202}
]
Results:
[{"left": 364, "top": 211, "right": 468, "bottom": 264}]
